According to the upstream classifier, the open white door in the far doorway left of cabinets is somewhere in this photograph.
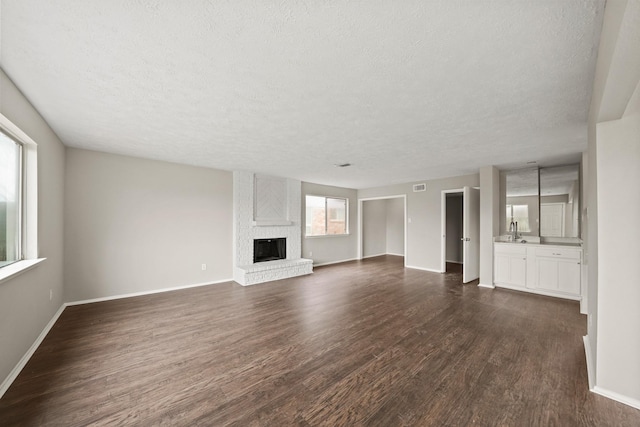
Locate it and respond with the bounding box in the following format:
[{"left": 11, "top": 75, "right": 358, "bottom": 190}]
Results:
[{"left": 462, "top": 187, "right": 480, "bottom": 283}]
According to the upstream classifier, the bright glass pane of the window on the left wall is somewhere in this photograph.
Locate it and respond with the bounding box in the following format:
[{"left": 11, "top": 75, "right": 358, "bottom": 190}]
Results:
[{"left": 0, "top": 133, "right": 21, "bottom": 267}]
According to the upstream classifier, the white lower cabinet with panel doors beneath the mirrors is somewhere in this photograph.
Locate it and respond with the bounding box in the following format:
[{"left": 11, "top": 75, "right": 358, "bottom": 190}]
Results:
[{"left": 494, "top": 243, "right": 582, "bottom": 299}]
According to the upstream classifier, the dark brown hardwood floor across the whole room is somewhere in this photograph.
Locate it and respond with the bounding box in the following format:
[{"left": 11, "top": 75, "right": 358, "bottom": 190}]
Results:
[{"left": 0, "top": 256, "right": 640, "bottom": 426}]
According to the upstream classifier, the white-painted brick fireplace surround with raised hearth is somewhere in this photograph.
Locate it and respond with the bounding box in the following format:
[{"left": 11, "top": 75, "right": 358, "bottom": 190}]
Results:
[{"left": 233, "top": 171, "right": 313, "bottom": 286}]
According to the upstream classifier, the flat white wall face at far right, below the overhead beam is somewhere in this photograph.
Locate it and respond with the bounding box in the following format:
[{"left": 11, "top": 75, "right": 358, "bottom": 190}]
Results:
[{"left": 596, "top": 113, "right": 640, "bottom": 404}]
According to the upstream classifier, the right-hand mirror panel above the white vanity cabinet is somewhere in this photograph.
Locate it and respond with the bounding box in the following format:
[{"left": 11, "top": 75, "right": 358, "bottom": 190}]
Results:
[{"left": 540, "top": 164, "right": 580, "bottom": 237}]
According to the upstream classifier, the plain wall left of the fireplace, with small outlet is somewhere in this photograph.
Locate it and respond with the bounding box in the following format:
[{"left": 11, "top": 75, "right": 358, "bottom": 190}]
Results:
[{"left": 64, "top": 148, "right": 233, "bottom": 301}]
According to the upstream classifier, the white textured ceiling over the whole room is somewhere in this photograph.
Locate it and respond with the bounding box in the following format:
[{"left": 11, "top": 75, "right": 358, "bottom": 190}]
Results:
[{"left": 0, "top": 0, "right": 604, "bottom": 188}]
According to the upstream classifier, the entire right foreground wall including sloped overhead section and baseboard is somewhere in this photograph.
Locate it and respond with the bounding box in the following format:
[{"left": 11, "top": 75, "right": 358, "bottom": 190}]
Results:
[{"left": 582, "top": 0, "right": 640, "bottom": 409}]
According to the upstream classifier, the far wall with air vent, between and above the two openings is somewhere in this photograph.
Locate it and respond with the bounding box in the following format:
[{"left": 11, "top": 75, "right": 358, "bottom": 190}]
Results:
[{"left": 358, "top": 174, "right": 479, "bottom": 271}]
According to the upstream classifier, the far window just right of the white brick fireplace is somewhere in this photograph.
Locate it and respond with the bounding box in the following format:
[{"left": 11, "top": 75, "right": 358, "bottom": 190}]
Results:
[{"left": 305, "top": 196, "right": 349, "bottom": 236}]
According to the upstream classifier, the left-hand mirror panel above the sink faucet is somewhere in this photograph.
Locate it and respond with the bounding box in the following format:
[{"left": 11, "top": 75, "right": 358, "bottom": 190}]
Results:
[{"left": 500, "top": 168, "right": 539, "bottom": 236}]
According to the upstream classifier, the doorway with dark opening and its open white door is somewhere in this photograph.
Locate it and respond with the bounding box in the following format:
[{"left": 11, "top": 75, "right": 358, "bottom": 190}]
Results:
[{"left": 440, "top": 187, "right": 480, "bottom": 283}]
